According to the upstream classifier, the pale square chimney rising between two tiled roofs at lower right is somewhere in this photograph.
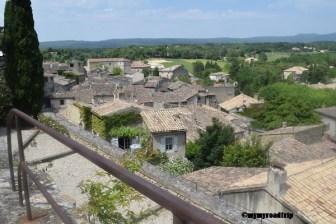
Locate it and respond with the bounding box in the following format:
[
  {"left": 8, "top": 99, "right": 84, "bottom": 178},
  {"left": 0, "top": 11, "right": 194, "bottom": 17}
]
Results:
[{"left": 266, "top": 162, "right": 287, "bottom": 198}]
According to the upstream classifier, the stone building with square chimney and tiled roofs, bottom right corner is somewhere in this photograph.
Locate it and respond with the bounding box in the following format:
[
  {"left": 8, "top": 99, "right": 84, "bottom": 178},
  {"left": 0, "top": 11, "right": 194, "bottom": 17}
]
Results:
[{"left": 185, "top": 157, "right": 336, "bottom": 224}]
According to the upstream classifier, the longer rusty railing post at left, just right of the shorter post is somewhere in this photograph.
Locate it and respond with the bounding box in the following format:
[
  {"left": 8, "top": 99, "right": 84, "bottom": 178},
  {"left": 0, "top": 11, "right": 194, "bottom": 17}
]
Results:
[{"left": 15, "top": 116, "right": 33, "bottom": 220}]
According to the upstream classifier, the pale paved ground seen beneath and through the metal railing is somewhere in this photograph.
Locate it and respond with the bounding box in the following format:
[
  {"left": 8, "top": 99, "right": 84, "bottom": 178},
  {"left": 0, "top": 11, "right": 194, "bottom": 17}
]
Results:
[{"left": 0, "top": 129, "right": 172, "bottom": 224}]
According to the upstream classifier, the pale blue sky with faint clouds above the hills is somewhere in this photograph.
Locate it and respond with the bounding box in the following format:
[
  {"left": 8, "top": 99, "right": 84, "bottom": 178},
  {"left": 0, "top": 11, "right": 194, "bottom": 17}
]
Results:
[{"left": 0, "top": 0, "right": 336, "bottom": 41}]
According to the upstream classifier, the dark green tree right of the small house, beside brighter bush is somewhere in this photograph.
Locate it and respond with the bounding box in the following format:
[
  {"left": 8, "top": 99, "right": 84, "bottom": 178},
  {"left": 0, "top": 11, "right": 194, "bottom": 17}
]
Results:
[{"left": 187, "top": 118, "right": 235, "bottom": 169}]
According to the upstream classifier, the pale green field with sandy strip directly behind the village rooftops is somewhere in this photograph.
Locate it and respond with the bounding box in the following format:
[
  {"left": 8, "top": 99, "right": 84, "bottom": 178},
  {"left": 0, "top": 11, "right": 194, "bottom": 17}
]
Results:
[{"left": 149, "top": 58, "right": 229, "bottom": 73}]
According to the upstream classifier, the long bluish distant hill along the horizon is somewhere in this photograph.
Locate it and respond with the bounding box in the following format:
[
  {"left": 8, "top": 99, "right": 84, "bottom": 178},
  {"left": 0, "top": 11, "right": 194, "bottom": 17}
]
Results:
[{"left": 40, "top": 33, "right": 336, "bottom": 48}]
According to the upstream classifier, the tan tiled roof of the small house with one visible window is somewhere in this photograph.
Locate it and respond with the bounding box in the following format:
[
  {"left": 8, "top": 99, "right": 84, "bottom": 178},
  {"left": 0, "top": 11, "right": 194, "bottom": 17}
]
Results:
[{"left": 141, "top": 110, "right": 186, "bottom": 133}]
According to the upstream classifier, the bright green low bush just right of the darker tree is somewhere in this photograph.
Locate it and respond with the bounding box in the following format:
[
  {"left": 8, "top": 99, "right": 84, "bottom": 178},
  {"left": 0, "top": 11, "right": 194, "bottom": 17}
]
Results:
[{"left": 222, "top": 137, "right": 270, "bottom": 167}]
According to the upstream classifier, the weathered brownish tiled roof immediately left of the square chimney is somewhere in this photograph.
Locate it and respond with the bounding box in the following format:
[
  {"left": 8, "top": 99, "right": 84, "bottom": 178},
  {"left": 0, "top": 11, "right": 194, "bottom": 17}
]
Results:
[{"left": 184, "top": 167, "right": 268, "bottom": 195}]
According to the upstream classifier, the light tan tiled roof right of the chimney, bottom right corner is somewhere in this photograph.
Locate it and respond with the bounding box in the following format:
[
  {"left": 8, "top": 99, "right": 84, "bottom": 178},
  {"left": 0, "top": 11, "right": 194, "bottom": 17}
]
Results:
[{"left": 283, "top": 159, "right": 336, "bottom": 224}]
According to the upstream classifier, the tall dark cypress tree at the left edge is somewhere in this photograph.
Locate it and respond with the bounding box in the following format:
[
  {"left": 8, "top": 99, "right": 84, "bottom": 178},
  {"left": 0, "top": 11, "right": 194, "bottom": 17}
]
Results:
[{"left": 4, "top": 0, "right": 44, "bottom": 116}]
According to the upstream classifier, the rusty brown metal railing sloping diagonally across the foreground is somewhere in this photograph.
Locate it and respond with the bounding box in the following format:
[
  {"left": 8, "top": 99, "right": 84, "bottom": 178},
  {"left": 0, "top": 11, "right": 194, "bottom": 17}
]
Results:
[{"left": 7, "top": 109, "right": 224, "bottom": 224}]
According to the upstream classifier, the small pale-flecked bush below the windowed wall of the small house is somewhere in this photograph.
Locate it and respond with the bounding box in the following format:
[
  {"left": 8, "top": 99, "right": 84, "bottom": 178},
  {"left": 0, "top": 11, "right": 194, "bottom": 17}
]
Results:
[{"left": 161, "top": 158, "right": 194, "bottom": 176}]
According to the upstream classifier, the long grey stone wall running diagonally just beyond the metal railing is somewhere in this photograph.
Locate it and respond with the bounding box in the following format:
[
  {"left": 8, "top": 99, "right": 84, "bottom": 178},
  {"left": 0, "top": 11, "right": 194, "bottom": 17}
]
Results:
[{"left": 47, "top": 114, "right": 274, "bottom": 224}]
